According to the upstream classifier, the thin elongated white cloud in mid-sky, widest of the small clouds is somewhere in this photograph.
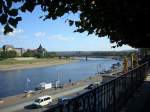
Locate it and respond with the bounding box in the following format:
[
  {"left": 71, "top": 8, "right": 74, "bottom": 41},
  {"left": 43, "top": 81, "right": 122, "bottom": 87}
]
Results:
[{"left": 48, "top": 35, "right": 74, "bottom": 41}]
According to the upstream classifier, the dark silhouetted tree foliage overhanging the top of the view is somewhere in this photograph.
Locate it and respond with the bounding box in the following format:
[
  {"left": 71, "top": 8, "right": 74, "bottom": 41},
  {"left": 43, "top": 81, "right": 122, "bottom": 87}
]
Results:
[{"left": 0, "top": 0, "right": 150, "bottom": 47}]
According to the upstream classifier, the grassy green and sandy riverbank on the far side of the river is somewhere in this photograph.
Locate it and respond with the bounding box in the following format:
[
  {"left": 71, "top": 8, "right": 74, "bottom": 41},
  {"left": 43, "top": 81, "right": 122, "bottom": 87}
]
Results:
[{"left": 0, "top": 58, "right": 74, "bottom": 71}]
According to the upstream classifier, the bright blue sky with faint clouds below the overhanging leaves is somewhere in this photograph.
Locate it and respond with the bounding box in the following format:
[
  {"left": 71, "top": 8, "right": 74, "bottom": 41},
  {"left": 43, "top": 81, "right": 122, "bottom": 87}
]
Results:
[{"left": 0, "top": 6, "right": 134, "bottom": 51}]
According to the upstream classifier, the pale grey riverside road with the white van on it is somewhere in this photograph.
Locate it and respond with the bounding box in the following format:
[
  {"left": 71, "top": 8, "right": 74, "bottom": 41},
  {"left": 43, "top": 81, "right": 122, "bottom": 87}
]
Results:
[{"left": 0, "top": 76, "right": 101, "bottom": 112}]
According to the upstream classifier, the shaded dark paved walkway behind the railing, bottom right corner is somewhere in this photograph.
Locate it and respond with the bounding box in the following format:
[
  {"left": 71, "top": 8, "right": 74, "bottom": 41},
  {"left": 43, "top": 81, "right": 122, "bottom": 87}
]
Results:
[{"left": 120, "top": 74, "right": 150, "bottom": 112}]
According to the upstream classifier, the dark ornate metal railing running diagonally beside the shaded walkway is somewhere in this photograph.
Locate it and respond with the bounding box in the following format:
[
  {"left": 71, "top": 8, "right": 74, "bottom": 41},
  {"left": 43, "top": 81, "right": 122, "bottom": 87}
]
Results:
[{"left": 45, "top": 57, "right": 150, "bottom": 112}]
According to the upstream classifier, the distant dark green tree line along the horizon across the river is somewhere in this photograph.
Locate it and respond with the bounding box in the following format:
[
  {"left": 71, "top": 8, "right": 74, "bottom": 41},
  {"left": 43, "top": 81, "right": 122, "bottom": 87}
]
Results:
[{"left": 0, "top": 50, "right": 136, "bottom": 59}]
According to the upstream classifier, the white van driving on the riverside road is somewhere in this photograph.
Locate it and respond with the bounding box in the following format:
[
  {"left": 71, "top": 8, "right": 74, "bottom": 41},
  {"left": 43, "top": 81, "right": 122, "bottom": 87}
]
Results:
[{"left": 33, "top": 95, "right": 52, "bottom": 107}]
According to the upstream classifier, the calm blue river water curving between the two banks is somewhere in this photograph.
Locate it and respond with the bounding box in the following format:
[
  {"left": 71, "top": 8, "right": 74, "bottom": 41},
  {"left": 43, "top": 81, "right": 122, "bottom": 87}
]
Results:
[{"left": 0, "top": 58, "right": 120, "bottom": 98}]
